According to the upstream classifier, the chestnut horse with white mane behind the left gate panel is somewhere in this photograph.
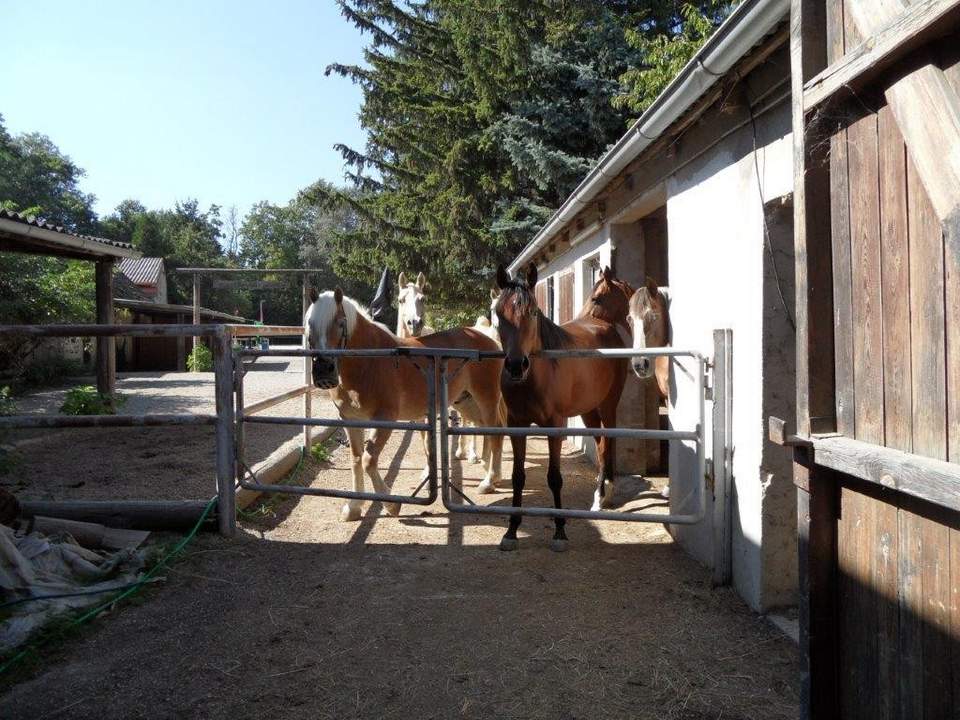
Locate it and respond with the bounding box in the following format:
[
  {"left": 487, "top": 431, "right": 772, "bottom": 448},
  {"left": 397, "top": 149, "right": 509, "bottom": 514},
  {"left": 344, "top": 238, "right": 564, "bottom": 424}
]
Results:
[{"left": 303, "top": 288, "right": 503, "bottom": 520}]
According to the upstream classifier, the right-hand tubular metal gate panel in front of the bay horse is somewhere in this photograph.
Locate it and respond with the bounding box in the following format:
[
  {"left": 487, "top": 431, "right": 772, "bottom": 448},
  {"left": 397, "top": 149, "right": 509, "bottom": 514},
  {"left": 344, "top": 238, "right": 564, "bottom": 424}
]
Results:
[{"left": 440, "top": 348, "right": 707, "bottom": 525}]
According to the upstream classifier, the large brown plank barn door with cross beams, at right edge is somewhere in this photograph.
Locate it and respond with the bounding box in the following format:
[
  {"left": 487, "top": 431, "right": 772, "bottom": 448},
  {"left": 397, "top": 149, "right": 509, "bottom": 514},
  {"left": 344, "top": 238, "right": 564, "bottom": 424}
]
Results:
[{"left": 792, "top": 0, "right": 960, "bottom": 720}]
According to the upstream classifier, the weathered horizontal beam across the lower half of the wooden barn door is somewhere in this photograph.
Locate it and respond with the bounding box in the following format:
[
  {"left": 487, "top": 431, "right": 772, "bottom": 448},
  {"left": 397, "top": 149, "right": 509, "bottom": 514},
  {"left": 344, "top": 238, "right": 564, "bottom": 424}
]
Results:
[{"left": 812, "top": 437, "right": 960, "bottom": 511}]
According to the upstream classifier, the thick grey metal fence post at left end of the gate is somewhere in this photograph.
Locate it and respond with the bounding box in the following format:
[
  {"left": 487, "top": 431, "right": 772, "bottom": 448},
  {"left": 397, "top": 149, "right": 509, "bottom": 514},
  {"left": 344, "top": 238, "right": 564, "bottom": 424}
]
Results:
[{"left": 211, "top": 327, "right": 237, "bottom": 537}]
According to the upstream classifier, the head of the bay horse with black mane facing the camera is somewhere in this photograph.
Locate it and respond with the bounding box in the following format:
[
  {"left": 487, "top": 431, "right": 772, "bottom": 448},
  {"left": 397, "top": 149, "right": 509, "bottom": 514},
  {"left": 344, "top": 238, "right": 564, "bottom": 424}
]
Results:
[{"left": 491, "top": 264, "right": 540, "bottom": 383}]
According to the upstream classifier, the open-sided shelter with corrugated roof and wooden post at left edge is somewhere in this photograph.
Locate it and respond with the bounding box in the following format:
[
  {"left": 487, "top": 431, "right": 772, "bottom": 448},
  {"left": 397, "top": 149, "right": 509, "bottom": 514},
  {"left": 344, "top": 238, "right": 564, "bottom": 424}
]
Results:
[{"left": 0, "top": 209, "right": 140, "bottom": 393}]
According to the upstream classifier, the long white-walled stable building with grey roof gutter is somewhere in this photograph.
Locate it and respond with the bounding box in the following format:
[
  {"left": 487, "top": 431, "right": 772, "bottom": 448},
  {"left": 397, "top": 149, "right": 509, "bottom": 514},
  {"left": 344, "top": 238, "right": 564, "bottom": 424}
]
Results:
[{"left": 510, "top": 0, "right": 797, "bottom": 611}]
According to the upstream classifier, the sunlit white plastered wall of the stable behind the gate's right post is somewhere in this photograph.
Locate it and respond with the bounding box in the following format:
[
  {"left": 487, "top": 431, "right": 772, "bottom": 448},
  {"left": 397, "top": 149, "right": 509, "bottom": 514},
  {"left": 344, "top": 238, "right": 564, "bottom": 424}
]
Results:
[{"left": 667, "top": 102, "right": 796, "bottom": 610}]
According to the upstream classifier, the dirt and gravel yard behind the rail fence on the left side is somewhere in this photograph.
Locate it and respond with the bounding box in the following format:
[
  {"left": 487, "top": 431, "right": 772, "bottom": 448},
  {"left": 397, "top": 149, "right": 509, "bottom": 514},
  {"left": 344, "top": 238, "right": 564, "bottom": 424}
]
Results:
[{"left": 0, "top": 350, "right": 336, "bottom": 500}]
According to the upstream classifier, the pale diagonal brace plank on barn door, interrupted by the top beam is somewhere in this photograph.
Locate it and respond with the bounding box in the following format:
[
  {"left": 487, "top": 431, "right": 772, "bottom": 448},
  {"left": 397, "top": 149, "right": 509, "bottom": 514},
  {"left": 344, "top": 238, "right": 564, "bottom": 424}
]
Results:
[{"left": 848, "top": 0, "right": 960, "bottom": 226}]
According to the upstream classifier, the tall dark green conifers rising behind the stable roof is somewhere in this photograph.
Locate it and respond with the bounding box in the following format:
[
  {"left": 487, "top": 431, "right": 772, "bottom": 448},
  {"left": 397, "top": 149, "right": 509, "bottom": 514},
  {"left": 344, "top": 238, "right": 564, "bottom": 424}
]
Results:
[{"left": 326, "top": 0, "right": 730, "bottom": 315}]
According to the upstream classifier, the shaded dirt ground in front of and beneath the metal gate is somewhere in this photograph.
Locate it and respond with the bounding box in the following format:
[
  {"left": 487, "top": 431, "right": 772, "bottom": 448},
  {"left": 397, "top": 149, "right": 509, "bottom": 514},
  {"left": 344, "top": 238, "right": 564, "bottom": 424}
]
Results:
[{"left": 0, "top": 434, "right": 798, "bottom": 720}]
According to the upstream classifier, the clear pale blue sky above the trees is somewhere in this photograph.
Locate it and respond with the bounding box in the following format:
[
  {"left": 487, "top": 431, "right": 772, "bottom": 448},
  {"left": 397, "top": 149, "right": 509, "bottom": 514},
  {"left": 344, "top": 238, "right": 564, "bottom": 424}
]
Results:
[{"left": 0, "top": 0, "right": 368, "bottom": 219}]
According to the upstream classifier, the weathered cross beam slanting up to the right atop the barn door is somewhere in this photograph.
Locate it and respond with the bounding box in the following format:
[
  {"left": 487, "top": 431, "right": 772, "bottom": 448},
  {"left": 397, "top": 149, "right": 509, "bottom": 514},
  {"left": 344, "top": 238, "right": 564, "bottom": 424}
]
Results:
[{"left": 803, "top": 0, "right": 960, "bottom": 112}]
